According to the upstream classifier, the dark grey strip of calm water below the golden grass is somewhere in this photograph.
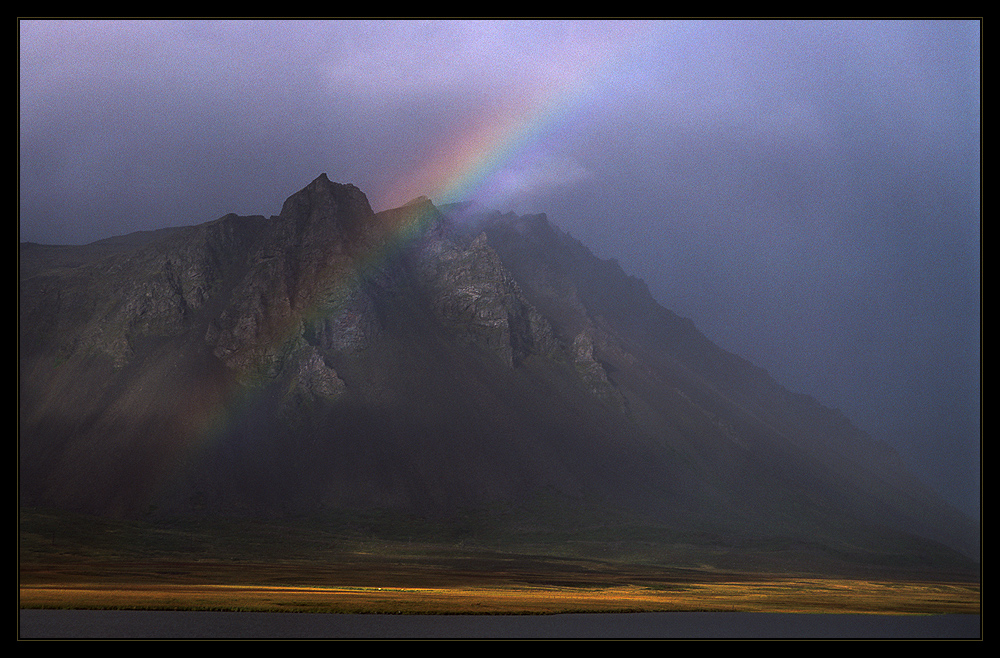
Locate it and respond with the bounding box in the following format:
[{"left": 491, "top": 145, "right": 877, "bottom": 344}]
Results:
[{"left": 18, "top": 610, "right": 982, "bottom": 639}]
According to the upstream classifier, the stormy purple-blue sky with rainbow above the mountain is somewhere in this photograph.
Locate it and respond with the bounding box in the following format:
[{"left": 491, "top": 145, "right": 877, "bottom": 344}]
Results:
[{"left": 18, "top": 20, "right": 981, "bottom": 515}]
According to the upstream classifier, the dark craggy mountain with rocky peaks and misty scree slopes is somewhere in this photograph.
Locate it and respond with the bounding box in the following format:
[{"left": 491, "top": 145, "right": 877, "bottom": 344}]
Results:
[{"left": 18, "top": 174, "right": 979, "bottom": 565}]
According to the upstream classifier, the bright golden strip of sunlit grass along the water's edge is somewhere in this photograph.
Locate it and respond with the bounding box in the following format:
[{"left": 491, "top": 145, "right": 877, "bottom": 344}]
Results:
[{"left": 20, "top": 578, "right": 980, "bottom": 614}]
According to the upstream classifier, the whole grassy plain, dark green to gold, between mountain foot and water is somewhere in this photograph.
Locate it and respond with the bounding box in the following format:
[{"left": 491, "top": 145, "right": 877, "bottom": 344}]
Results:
[{"left": 19, "top": 513, "right": 980, "bottom": 614}]
